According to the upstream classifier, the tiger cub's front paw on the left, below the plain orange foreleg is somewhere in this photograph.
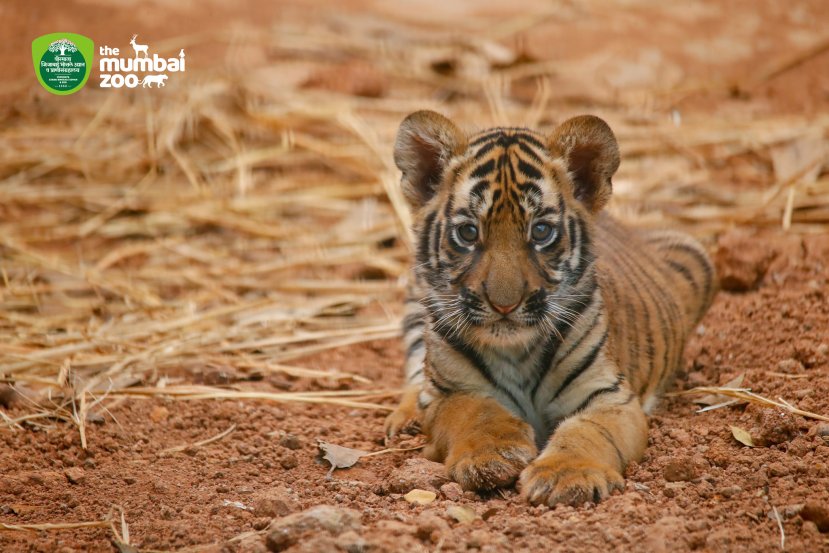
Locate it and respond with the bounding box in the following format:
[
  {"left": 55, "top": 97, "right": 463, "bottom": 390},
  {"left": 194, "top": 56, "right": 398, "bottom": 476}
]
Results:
[{"left": 446, "top": 435, "right": 537, "bottom": 491}]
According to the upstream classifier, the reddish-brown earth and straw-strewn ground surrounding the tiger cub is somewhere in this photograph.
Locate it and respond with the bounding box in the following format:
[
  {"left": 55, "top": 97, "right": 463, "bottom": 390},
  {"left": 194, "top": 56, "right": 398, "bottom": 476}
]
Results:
[{"left": 0, "top": 0, "right": 829, "bottom": 553}]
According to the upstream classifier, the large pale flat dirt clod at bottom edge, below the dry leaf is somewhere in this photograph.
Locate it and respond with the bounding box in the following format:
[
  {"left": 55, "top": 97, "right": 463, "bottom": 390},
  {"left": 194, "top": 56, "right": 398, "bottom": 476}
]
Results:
[{"left": 265, "top": 505, "right": 362, "bottom": 551}]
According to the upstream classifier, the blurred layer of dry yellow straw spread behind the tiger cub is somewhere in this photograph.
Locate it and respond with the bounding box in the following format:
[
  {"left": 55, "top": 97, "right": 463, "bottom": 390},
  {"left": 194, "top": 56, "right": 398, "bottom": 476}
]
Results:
[{"left": 0, "top": 12, "right": 829, "bottom": 445}]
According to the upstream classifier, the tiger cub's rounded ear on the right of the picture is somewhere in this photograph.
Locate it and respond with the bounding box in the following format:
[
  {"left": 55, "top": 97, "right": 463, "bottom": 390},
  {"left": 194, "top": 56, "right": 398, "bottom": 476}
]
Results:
[{"left": 549, "top": 115, "right": 619, "bottom": 213}]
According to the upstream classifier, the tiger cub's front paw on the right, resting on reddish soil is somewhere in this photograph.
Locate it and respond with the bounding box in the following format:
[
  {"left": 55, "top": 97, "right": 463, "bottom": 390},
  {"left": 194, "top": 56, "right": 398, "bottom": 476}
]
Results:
[{"left": 520, "top": 453, "right": 624, "bottom": 507}]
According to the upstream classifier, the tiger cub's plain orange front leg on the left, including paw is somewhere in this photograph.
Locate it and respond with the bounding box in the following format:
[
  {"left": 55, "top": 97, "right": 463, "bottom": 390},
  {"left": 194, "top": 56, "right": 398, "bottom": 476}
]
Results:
[{"left": 424, "top": 393, "right": 537, "bottom": 490}]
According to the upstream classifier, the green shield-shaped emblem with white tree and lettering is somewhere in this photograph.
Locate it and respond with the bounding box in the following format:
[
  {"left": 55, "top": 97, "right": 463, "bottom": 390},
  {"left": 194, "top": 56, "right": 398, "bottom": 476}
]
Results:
[{"left": 32, "top": 33, "right": 95, "bottom": 96}]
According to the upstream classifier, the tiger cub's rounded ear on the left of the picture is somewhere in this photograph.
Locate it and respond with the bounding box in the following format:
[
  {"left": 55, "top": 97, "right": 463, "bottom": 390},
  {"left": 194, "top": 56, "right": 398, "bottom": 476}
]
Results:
[{"left": 394, "top": 110, "right": 466, "bottom": 209}]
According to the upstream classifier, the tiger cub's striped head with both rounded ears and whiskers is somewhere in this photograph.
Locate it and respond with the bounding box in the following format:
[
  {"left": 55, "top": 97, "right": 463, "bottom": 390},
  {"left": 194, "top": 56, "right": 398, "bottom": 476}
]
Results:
[{"left": 394, "top": 111, "right": 619, "bottom": 346}]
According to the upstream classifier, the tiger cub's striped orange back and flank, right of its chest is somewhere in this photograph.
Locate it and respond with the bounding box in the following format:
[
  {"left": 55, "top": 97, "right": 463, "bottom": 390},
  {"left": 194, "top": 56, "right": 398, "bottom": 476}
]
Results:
[{"left": 595, "top": 215, "right": 716, "bottom": 412}]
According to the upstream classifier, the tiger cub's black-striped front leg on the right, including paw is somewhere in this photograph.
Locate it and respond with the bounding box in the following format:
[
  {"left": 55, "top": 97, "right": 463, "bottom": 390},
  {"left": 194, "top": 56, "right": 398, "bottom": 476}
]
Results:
[{"left": 520, "top": 386, "right": 648, "bottom": 506}]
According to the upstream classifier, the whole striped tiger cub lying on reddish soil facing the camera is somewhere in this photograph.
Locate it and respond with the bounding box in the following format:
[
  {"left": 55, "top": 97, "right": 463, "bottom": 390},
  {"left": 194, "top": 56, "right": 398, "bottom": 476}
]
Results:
[{"left": 386, "top": 111, "right": 715, "bottom": 505}]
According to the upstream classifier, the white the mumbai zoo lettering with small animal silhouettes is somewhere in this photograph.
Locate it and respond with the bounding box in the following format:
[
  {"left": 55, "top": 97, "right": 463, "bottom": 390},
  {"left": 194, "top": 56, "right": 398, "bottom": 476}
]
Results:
[{"left": 98, "top": 35, "right": 185, "bottom": 88}]
